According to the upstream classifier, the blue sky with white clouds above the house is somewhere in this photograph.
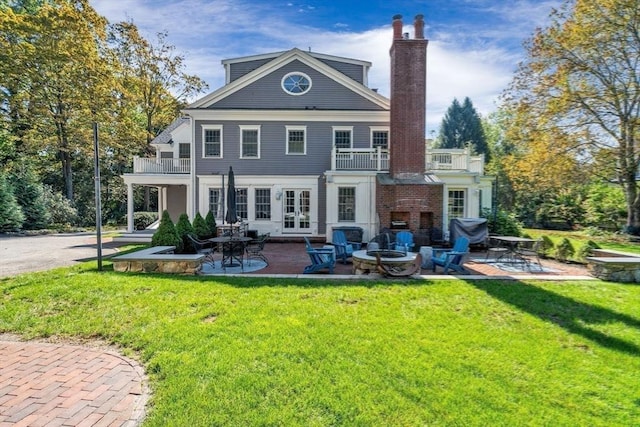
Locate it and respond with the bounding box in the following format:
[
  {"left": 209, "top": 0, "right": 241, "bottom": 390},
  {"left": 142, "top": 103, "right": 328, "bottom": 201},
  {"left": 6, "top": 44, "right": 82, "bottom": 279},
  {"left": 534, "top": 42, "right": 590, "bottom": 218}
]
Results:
[{"left": 91, "top": 0, "right": 562, "bottom": 136}]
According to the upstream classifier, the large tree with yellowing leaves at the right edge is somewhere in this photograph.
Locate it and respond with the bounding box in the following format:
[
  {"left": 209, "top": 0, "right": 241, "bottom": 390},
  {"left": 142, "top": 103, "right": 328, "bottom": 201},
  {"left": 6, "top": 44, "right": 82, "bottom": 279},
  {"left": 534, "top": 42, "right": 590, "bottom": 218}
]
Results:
[{"left": 505, "top": 0, "right": 640, "bottom": 231}]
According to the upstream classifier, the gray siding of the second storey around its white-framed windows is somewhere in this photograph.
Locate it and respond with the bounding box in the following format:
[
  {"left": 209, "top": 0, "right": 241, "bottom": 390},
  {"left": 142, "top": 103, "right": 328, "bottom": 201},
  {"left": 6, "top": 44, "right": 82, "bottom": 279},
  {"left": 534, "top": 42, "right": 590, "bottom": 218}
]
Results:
[{"left": 195, "top": 118, "right": 382, "bottom": 175}]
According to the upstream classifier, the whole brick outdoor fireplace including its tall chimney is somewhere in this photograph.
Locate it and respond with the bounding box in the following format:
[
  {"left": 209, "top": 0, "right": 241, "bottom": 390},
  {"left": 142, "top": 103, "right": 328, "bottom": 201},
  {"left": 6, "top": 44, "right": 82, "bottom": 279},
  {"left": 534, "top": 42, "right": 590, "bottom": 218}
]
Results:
[{"left": 376, "top": 15, "right": 443, "bottom": 244}]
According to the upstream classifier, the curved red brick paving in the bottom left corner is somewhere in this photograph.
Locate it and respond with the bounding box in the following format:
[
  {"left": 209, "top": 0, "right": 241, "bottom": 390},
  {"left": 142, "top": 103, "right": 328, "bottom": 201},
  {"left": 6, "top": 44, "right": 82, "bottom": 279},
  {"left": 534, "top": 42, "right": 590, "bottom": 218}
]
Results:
[{"left": 0, "top": 335, "right": 148, "bottom": 427}]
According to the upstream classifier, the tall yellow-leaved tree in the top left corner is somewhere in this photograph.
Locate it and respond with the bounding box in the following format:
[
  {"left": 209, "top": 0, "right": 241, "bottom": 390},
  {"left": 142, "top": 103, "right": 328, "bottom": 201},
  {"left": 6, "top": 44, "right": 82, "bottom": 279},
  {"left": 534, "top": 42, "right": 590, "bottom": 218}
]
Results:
[{"left": 0, "top": 0, "right": 113, "bottom": 200}]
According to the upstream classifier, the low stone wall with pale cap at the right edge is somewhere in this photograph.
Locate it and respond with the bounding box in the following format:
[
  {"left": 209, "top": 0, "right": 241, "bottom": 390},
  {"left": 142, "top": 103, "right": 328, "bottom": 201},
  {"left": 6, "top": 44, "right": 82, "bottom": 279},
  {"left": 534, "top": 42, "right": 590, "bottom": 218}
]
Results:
[{"left": 586, "top": 249, "right": 640, "bottom": 283}]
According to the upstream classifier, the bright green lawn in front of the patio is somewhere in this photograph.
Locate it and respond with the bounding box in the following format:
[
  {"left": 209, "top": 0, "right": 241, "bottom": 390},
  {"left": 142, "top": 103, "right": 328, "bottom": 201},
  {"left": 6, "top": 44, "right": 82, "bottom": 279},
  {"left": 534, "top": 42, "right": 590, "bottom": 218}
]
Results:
[{"left": 0, "top": 263, "right": 640, "bottom": 426}]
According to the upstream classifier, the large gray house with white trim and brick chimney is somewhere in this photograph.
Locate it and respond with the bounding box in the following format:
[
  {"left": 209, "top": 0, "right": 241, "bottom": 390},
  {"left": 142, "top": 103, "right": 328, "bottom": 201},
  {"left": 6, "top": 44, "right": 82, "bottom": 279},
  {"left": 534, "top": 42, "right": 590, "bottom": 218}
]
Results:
[{"left": 123, "top": 15, "right": 493, "bottom": 241}]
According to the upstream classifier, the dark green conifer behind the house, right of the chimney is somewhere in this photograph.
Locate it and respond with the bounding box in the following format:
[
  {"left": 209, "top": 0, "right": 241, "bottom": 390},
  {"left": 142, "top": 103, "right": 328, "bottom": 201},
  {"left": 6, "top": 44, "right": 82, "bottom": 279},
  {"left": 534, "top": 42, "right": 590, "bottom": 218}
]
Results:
[{"left": 438, "top": 97, "right": 489, "bottom": 161}]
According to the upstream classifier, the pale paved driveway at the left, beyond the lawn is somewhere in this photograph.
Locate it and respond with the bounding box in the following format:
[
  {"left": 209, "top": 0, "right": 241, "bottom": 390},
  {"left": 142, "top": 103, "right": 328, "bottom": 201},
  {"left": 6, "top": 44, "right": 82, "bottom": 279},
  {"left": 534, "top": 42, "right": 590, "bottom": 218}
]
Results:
[{"left": 0, "top": 233, "right": 119, "bottom": 277}]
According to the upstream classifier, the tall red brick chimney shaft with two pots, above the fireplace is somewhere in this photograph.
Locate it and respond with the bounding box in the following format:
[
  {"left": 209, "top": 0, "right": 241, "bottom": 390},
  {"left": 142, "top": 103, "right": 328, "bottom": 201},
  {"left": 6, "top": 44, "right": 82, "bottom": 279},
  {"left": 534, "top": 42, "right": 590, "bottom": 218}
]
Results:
[{"left": 389, "top": 15, "right": 428, "bottom": 178}]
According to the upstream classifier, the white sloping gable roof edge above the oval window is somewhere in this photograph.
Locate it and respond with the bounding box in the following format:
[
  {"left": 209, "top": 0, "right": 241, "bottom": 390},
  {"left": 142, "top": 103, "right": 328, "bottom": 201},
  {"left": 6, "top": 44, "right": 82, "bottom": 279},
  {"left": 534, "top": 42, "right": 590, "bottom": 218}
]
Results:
[{"left": 186, "top": 48, "right": 389, "bottom": 110}]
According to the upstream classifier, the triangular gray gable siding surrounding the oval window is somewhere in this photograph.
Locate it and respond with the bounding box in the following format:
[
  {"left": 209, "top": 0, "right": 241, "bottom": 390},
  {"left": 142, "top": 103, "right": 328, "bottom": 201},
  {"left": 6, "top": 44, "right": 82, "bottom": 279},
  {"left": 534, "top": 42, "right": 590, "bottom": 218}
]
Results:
[{"left": 209, "top": 61, "right": 384, "bottom": 111}]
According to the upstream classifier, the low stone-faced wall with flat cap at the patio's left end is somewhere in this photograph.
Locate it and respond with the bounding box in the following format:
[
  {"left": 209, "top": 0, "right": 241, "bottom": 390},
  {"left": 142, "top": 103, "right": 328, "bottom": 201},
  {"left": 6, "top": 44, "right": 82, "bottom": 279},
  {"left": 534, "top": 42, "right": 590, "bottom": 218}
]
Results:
[{"left": 112, "top": 246, "right": 205, "bottom": 274}]
